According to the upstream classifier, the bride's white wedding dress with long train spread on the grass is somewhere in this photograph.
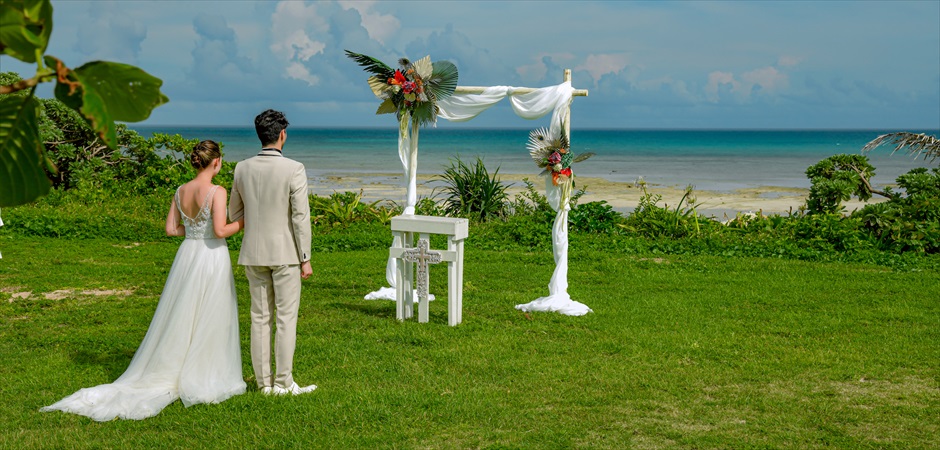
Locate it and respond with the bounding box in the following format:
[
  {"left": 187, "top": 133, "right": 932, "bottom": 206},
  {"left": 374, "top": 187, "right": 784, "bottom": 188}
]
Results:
[{"left": 40, "top": 186, "right": 245, "bottom": 421}]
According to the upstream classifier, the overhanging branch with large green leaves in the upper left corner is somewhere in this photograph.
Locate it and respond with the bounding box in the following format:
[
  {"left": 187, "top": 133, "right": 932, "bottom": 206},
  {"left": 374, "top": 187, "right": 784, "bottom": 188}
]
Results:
[{"left": 0, "top": 0, "right": 168, "bottom": 206}]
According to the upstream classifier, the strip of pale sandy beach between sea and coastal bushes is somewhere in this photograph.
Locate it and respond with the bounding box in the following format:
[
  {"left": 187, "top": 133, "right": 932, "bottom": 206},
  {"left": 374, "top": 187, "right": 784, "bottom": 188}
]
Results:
[{"left": 310, "top": 173, "right": 883, "bottom": 220}]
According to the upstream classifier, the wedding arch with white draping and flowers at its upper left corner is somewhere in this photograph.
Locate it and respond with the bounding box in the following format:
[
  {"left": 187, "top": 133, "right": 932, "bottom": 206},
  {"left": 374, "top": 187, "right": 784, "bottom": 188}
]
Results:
[{"left": 347, "top": 52, "right": 591, "bottom": 316}]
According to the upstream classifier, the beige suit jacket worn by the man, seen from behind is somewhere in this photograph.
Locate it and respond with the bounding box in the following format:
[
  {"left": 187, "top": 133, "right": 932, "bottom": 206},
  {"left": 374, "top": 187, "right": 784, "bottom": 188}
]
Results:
[{"left": 228, "top": 149, "right": 310, "bottom": 266}]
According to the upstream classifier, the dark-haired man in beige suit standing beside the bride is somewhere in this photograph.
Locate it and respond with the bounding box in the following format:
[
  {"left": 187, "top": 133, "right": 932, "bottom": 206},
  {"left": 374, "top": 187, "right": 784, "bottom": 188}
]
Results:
[{"left": 228, "top": 109, "right": 317, "bottom": 395}]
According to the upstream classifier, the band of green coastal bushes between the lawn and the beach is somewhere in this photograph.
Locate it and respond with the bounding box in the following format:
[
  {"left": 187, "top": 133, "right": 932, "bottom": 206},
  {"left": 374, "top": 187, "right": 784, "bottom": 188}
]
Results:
[{"left": 0, "top": 118, "right": 940, "bottom": 268}]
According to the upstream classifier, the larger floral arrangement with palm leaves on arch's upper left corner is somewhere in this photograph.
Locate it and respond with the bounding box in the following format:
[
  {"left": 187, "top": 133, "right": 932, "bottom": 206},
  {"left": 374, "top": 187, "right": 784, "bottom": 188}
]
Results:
[{"left": 346, "top": 50, "right": 457, "bottom": 126}]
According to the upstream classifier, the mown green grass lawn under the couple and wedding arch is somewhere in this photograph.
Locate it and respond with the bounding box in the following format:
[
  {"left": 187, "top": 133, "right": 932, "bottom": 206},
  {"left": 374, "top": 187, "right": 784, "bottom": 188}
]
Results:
[{"left": 0, "top": 231, "right": 940, "bottom": 449}]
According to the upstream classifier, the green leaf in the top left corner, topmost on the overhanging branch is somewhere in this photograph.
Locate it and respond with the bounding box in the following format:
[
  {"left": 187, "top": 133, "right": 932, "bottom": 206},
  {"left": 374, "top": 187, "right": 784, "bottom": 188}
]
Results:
[{"left": 0, "top": 0, "right": 52, "bottom": 63}]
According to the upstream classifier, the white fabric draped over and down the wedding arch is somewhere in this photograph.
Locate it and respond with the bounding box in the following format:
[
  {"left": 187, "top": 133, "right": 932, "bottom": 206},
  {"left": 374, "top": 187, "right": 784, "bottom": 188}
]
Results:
[{"left": 365, "top": 81, "right": 591, "bottom": 316}]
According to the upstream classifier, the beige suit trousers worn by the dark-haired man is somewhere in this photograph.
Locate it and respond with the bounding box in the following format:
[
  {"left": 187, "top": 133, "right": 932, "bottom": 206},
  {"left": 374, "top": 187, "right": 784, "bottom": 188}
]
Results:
[{"left": 245, "top": 264, "right": 300, "bottom": 388}]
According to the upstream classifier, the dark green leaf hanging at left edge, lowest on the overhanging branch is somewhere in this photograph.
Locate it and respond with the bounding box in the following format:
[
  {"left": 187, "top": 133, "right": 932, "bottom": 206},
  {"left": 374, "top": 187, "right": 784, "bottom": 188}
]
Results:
[{"left": 0, "top": 95, "right": 51, "bottom": 207}]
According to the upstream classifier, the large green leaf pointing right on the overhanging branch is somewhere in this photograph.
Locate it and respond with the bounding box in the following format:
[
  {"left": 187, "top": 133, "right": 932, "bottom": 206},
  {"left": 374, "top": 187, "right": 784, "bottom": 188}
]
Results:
[{"left": 46, "top": 56, "right": 169, "bottom": 148}]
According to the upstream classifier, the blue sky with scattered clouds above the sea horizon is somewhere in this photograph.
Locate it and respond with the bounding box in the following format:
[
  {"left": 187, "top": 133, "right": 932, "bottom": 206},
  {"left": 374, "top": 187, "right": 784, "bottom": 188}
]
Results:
[{"left": 0, "top": 0, "right": 940, "bottom": 131}]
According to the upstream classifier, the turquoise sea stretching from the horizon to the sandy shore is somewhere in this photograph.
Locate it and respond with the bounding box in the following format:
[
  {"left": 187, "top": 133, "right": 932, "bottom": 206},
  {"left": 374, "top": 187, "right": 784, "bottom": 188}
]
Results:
[{"left": 134, "top": 126, "right": 940, "bottom": 191}]
